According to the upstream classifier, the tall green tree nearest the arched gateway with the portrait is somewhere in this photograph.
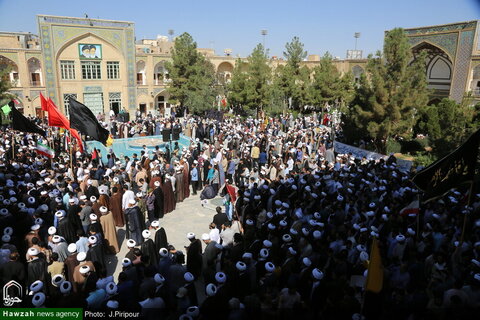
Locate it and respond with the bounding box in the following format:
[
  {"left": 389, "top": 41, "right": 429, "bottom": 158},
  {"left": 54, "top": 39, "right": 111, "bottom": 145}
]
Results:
[{"left": 166, "top": 33, "right": 216, "bottom": 113}]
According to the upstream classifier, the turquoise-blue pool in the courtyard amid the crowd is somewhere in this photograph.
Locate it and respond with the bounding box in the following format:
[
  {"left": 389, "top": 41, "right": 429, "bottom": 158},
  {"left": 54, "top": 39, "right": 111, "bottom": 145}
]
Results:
[{"left": 87, "top": 134, "right": 191, "bottom": 162}]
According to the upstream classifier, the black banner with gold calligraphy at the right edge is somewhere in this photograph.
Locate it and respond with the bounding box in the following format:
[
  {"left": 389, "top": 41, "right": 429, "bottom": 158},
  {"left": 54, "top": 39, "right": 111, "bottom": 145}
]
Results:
[{"left": 413, "top": 130, "right": 480, "bottom": 202}]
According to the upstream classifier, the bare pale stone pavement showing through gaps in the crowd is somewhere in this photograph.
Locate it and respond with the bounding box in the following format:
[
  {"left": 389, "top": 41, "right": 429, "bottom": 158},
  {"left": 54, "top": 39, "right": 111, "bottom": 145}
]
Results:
[{"left": 103, "top": 193, "right": 222, "bottom": 300}]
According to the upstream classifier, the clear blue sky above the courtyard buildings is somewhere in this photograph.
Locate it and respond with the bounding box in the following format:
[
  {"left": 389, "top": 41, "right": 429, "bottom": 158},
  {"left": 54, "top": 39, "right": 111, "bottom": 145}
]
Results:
[{"left": 0, "top": 0, "right": 480, "bottom": 59}]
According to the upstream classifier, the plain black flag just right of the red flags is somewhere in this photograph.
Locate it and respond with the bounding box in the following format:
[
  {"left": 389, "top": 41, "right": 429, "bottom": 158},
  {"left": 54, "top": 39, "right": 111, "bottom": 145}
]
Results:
[{"left": 69, "top": 98, "right": 109, "bottom": 145}]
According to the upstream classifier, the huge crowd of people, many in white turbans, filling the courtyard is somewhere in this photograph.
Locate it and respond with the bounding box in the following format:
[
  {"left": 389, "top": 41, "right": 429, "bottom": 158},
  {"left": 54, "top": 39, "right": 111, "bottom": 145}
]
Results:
[{"left": 0, "top": 110, "right": 480, "bottom": 320}]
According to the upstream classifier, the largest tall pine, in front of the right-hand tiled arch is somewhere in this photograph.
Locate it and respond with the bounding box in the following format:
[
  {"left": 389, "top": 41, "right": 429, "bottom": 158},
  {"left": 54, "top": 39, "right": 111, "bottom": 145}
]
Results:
[{"left": 350, "top": 28, "right": 429, "bottom": 153}]
